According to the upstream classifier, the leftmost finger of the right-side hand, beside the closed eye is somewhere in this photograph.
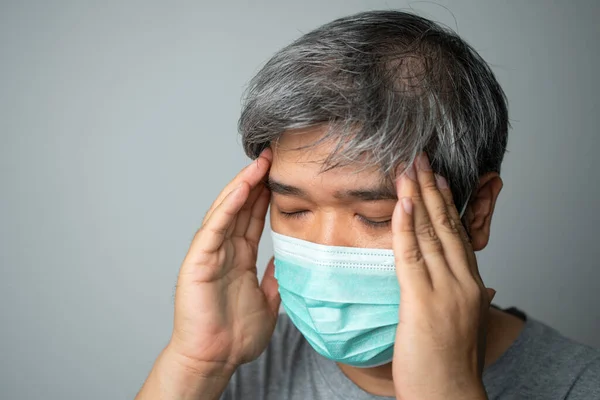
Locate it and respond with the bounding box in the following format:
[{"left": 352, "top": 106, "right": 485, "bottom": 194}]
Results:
[{"left": 392, "top": 175, "right": 431, "bottom": 291}]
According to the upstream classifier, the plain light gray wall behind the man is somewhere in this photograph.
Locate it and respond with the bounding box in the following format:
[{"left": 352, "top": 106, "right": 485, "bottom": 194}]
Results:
[{"left": 0, "top": 0, "right": 600, "bottom": 400}]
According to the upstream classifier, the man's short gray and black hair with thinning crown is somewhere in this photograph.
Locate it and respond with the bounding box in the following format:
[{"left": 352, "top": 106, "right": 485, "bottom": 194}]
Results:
[{"left": 239, "top": 11, "right": 509, "bottom": 211}]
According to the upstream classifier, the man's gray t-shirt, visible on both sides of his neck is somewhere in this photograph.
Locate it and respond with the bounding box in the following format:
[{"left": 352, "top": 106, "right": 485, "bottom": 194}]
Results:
[{"left": 221, "top": 314, "right": 600, "bottom": 400}]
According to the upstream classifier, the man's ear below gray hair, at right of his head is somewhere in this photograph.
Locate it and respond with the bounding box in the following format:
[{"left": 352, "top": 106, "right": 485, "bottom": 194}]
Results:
[{"left": 465, "top": 172, "right": 503, "bottom": 251}]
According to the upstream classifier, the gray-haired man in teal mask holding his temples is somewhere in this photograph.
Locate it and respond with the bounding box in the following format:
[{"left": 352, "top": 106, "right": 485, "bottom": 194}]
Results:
[{"left": 138, "top": 11, "right": 600, "bottom": 400}]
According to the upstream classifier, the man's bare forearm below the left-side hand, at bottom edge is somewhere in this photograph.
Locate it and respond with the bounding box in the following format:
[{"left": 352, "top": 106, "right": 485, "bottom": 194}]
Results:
[{"left": 135, "top": 348, "right": 233, "bottom": 400}]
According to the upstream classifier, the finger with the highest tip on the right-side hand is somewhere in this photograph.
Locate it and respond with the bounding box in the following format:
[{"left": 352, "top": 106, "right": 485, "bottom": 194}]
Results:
[{"left": 415, "top": 153, "right": 471, "bottom": 279}]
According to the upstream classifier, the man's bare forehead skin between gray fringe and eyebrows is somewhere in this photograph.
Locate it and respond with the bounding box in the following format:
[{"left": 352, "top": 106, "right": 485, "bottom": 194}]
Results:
[{"left": 270, "top": 127, "right": 386, "bottom": 189}]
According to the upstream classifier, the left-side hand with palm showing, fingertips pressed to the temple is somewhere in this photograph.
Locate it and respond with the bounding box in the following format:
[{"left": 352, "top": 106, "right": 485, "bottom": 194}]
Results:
[{"left": 168, "top": 149, "right": 280, "bottom": 374}]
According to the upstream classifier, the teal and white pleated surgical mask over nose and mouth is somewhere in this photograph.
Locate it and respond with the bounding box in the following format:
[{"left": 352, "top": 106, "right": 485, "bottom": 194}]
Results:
[{"left": 272, "top": 198, "right": 466, "bottom": 368}]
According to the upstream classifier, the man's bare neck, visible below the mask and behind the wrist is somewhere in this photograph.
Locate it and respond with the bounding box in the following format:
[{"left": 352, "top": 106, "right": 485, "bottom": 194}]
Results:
[{"left": 338, "top": 308, "right": 524, "bottom": 397}]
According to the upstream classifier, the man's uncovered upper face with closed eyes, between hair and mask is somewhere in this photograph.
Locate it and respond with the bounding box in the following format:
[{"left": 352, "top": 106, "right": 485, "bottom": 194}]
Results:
[{"left": 268, "top": 128, "right": 396, "bottom": 249}]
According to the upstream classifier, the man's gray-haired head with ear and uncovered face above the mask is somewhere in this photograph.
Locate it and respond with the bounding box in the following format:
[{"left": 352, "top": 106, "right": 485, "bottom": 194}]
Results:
[{"left": 239, "top": 11, "right": 508, "bottom": 249}]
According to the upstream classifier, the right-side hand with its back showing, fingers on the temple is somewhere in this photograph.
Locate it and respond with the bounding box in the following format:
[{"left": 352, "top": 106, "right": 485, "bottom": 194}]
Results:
[{"left": 392, "top": 153, "right": 495, "bottom": 400}]
